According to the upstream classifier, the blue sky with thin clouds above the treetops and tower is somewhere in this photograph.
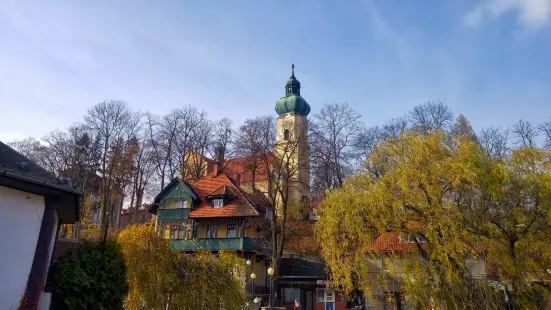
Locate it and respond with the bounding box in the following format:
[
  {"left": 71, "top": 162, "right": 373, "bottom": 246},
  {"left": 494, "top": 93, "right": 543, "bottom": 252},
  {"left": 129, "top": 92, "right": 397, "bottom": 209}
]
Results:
[{"left": 0, "top": 0, "right": 551, "bottom": 141}]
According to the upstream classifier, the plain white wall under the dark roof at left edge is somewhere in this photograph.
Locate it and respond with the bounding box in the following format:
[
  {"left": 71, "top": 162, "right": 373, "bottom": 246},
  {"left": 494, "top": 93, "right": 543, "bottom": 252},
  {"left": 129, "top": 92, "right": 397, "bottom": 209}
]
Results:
[{"left": 0, "top": 186, "right": 44, "bottom": 310}]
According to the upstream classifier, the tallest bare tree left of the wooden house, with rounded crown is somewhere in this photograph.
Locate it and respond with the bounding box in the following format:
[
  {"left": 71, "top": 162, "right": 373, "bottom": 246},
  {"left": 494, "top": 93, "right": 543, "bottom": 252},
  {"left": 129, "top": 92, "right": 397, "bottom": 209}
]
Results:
[{"left": 84, "top": 100, "right": 137, "bottom": 236}]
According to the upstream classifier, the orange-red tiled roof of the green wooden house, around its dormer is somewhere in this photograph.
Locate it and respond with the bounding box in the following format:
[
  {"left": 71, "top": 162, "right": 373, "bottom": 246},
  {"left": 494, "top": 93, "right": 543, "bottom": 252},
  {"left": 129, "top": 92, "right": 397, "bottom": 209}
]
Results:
[{"left": 189, "top": 173, "right": 259, "bottom": 218}]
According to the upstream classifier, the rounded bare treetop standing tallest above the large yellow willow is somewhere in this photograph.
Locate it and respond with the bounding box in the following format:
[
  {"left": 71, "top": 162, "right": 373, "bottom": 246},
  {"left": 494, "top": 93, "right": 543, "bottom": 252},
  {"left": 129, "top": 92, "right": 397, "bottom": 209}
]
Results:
[{"left": 409, "top": 101, "right": 453, "bottom": 132}]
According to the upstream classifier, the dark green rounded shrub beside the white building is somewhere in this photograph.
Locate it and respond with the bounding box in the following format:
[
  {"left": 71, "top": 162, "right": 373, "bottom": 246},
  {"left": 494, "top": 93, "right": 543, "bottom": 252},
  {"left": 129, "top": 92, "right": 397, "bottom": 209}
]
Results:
[{"left": 48, "top": 240, "right": 128, "bottom": 310}]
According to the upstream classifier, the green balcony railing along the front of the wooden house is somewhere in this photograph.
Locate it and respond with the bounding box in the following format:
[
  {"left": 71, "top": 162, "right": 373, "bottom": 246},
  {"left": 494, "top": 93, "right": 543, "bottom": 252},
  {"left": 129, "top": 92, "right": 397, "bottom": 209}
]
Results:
[{"left": 172, "top": 238, "right": 269, "bottom": 254}]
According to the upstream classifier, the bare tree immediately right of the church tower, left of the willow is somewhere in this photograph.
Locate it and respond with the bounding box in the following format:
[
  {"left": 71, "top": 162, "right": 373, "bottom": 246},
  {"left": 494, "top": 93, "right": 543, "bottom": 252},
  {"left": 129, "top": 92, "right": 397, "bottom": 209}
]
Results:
[{"left": 309, "top": 102, "right": 362, "bottom": 190}]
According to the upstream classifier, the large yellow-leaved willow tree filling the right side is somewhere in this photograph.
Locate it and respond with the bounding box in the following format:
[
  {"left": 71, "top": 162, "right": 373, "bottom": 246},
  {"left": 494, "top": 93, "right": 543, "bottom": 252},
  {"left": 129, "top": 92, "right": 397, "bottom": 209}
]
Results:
[{"left": 315, "top": 131, "right": 551, "bottom": 309}]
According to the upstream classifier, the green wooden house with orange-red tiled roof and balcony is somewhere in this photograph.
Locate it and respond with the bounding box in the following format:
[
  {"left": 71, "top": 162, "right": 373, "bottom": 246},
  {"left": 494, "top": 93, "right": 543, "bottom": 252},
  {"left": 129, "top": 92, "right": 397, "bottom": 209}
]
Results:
[{"left": 150, "top": 165, "right": 270, "bottom": 294}]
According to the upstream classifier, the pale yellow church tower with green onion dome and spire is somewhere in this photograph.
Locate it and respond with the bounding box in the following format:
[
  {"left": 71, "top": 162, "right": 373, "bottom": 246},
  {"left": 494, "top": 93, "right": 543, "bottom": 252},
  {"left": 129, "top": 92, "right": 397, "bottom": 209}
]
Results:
[{"left": 275, "top": 64, "right": 310, "bottom": 203}]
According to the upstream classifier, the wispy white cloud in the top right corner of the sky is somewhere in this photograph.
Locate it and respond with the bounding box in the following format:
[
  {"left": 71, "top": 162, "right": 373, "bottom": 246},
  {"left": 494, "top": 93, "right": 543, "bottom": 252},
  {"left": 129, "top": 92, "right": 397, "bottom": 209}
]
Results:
[{"left": 463, "top": 0, "right": 551, "bottom": 32}]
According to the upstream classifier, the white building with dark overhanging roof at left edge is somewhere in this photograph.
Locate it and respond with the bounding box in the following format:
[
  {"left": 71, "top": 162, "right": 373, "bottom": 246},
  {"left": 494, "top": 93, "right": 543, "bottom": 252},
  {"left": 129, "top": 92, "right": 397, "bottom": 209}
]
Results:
[{"left": 0, "top": 142, "right": 81, "bottom": 309}]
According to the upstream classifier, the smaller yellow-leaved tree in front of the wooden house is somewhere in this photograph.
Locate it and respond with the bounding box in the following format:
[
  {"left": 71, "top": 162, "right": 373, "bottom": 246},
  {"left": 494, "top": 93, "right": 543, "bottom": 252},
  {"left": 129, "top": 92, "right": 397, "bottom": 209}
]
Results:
[{"left": 118, "top": 225, "right": 246, "bottom": 310}]
